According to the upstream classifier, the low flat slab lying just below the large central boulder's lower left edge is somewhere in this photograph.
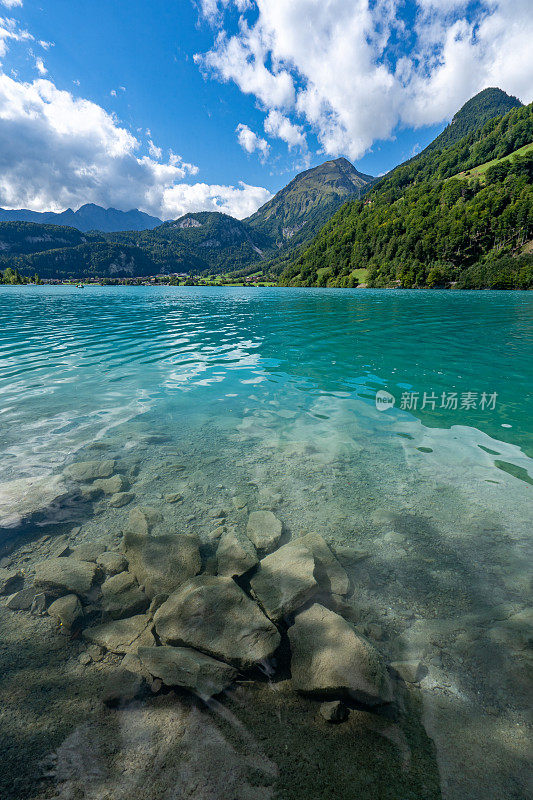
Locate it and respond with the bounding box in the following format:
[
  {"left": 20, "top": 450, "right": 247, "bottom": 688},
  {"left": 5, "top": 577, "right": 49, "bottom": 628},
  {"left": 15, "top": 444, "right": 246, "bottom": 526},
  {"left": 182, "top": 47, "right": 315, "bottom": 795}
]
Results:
[{"left": 138, "top": 646, "right": 237, "bottom": 698}]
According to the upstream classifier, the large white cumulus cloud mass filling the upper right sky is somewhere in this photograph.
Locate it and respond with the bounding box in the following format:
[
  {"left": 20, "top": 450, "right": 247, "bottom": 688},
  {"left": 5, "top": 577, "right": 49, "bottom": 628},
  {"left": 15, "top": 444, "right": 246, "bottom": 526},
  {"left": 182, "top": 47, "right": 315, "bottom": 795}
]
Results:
[{"left": 195, "top": 0, "right": 533, "bottom": 159}]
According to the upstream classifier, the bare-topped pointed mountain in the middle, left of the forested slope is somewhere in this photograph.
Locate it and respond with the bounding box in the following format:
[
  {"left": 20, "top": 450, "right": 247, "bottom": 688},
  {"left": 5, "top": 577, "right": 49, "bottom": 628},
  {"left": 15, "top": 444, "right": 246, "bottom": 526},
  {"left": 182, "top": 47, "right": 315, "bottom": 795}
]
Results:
[{"left": 244, "top": 158, "right": 376, "bottom": 249}]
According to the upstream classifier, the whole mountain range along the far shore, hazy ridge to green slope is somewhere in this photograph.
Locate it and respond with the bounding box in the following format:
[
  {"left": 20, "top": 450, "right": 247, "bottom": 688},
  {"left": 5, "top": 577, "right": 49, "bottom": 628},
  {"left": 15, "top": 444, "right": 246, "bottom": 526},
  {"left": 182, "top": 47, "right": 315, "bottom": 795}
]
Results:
[{"left": 0, "top": 89, "right": 533, "bottom": 286}]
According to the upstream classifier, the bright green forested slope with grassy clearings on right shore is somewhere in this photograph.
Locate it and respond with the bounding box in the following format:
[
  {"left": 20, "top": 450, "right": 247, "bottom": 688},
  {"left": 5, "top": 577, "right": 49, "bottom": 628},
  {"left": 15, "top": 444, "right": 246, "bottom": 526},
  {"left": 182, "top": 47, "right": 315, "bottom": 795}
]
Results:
[{"left": 281, "top": 90, "right": 533, "bottom": 288}]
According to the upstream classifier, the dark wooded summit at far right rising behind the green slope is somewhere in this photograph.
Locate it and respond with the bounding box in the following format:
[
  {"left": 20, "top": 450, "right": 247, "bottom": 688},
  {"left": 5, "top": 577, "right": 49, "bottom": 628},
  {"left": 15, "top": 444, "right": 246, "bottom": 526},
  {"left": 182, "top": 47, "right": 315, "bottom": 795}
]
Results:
[{"left": 420, "top": 89, "right": 522, "bottom": 155}]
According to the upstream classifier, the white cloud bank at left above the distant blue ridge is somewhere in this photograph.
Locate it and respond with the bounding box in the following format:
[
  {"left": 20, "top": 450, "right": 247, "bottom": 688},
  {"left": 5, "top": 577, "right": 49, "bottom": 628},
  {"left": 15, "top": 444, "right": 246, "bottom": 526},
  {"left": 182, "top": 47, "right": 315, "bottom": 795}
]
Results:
[{"left": 0, "top": 72, "right": 271, "bottom": 219}]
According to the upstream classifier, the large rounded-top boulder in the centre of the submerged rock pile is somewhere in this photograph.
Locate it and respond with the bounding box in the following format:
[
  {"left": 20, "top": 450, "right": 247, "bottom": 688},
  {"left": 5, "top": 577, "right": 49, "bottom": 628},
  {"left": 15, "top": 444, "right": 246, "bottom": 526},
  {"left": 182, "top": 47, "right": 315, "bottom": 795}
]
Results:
[{"left": 154, "top": 575, "right": 281, "bottom": 668}]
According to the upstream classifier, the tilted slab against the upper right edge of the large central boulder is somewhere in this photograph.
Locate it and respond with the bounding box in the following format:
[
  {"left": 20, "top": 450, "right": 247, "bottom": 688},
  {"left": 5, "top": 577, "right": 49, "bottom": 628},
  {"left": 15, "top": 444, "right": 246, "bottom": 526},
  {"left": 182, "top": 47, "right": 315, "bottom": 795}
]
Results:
[{"left": 250, "top": 539, "right": 319, "bottom": 620}]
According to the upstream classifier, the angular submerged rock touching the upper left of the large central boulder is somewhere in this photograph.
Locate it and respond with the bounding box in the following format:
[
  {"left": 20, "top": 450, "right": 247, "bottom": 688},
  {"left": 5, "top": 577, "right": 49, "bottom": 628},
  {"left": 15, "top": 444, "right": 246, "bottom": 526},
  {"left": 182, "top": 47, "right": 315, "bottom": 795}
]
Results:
[{"left": 122, "top": 530, "right": 202, "bottom": 599}]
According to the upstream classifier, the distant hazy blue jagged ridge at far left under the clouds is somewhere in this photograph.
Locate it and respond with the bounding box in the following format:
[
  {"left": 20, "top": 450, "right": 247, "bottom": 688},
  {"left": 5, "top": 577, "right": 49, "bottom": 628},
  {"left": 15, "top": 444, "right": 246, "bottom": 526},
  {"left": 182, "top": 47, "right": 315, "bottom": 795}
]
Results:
[{"left": 0, "top": 203, "right": 161, "bottom": 232}]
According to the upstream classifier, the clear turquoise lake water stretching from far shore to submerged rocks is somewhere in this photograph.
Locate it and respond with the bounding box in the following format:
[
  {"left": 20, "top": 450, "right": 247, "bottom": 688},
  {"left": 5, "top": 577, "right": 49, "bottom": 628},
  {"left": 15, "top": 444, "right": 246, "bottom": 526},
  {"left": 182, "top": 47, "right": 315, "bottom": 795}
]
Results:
[{"left": 0, "top": 287, "right": 533, "bottom": 798}]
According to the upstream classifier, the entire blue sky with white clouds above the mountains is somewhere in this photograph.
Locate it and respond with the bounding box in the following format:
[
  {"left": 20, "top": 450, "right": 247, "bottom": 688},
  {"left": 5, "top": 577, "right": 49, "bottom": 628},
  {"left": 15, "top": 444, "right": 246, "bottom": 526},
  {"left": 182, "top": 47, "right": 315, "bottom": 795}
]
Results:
[{"left": 0, "top": 0, "right": 533, "bottom": 219}]
